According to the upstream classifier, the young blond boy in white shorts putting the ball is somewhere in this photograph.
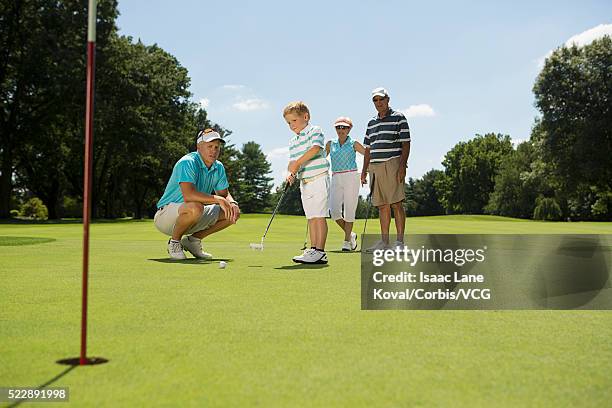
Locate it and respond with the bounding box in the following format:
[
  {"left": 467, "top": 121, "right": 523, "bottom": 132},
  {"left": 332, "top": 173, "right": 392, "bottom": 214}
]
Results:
[{"left": 283, "top": 102, "right": 329, "bottom": 264}]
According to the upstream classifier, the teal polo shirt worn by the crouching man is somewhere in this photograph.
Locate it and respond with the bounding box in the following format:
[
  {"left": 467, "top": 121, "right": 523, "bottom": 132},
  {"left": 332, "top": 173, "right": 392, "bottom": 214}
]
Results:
[{"left": 157, "top": 152, "right": 229, "bottom": 208}]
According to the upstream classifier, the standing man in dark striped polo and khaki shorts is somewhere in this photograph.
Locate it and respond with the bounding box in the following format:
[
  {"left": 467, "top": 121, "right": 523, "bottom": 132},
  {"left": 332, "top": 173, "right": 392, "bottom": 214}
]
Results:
[{"left": 361, "top": 88, "right": 410, "bottom": 251}]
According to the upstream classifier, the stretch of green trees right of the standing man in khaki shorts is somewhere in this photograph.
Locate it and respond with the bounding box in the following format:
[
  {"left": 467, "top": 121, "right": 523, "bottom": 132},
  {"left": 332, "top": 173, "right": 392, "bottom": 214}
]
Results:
[{"left": 406, "top": 36, "right": 612, "bottom": 221}]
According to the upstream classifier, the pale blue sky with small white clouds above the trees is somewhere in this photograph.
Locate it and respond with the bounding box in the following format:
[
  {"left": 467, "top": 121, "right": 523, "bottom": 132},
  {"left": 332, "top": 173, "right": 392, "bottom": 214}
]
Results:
[{"left": 117, "top": 0, "right": 612, "bottom": 190}]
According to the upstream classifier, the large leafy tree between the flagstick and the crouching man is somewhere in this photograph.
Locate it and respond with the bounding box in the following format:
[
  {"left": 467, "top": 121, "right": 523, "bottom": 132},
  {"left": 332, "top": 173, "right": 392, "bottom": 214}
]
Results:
[{"left": 93, "top": 37, "right": 197, "bottom": 218}]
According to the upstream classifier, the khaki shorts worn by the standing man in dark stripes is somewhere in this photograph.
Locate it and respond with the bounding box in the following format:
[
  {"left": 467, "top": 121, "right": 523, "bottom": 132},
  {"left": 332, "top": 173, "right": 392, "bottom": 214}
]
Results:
[{"left": 369, "top": 157, "right": 406, "bottom": 207}]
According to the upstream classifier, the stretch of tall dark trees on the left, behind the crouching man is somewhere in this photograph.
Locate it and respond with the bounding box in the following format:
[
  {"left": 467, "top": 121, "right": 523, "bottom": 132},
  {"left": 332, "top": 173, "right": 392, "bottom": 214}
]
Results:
[{"left": 0, "top": 0, "right": 272, "bottom": 218}]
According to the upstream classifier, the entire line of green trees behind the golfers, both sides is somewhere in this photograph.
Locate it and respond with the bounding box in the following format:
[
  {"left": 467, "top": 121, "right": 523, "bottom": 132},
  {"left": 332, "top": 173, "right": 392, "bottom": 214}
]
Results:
[{"left": 0, "top": 0, "right": 612, "bottom": 220}]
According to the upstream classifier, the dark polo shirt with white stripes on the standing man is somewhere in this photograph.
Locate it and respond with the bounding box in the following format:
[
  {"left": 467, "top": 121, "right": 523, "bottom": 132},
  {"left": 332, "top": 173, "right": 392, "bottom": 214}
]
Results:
[{"left": 363, "top": 108, "right": 410, "bottom": 163}]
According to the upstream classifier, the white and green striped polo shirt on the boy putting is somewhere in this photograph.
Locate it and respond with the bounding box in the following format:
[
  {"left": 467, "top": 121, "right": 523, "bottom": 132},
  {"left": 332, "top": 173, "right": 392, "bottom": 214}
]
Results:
[{"left": 289, "top": 125, "right": 329, "bottom": 181}]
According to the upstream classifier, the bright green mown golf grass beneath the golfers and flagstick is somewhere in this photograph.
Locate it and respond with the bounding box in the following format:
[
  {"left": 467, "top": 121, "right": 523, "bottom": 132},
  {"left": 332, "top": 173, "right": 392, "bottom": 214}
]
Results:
[{"left": 0, "top": 215, "right": 612, "bottom": 407}]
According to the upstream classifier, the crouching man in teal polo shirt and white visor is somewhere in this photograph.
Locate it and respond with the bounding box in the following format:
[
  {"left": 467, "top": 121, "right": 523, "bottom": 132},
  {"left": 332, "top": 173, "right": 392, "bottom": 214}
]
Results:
[{"left": 155, "top": 129, "right": 240, "bottom": 259}]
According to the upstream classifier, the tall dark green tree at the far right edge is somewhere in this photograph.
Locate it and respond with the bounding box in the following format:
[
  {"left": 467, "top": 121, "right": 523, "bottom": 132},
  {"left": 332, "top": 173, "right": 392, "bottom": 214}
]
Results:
[{"left": 533, "top": 36, "right": 612, "bottom": 195}]
